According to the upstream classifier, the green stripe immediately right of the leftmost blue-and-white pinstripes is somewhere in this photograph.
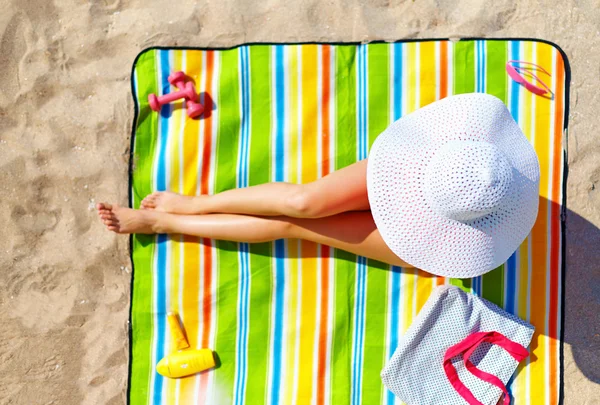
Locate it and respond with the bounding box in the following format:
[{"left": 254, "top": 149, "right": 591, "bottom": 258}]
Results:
[{"left": 246, "top": 46, "right": 273, "bottom": 404}]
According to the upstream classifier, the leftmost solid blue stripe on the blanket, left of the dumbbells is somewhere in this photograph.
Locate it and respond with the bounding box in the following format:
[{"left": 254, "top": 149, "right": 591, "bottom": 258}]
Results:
[{"left": 152, "top": 50, "right": 171, "bottom": 404}]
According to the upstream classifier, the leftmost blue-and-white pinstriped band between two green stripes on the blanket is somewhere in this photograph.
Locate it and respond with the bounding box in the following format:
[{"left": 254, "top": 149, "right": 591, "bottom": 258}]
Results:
[{"left": 234, "top": 46, "right": 250, "bottom": 405}]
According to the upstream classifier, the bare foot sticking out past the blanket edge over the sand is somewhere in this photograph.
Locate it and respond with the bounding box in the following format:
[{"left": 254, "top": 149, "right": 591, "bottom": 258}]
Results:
[{"left": 96, "top": 203, "right": 156, "bottom": 234}]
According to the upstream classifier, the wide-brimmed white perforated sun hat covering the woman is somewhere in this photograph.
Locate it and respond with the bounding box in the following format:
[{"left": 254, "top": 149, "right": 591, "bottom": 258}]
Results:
[{"left": 367, "top": 93, "right": 540, "bottom": 278}]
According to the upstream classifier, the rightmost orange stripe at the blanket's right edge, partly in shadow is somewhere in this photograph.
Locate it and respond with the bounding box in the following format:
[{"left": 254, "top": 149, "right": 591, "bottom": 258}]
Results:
[{"left": 548, "top": 50, "right": 565, "bottom": 404}]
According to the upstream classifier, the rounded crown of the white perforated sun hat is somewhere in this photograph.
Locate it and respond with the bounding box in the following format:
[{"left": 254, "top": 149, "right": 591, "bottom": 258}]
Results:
[{"left": 425, "top": 141, "right": 513, "bottom": 222}]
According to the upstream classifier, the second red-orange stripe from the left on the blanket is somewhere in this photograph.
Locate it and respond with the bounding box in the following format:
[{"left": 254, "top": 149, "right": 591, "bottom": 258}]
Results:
[{"left": 317, "top": 45, "right": 331, "bottom": 404}]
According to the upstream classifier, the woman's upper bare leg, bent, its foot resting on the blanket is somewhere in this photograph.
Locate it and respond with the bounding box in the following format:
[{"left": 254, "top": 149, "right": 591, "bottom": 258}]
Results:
[{"left": 142, "top": 160, "right": 369, "bottom": 218}]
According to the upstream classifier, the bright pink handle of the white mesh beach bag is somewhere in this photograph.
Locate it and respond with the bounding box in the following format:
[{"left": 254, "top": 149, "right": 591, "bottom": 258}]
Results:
[{"left": 444, "top": 332, "right": 529, "bottom": 405}]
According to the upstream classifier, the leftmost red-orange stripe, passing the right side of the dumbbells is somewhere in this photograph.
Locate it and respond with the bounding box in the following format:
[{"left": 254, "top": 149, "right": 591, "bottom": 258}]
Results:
[{"left": 199, "top": 51, "right": 215, "bottom": 403}]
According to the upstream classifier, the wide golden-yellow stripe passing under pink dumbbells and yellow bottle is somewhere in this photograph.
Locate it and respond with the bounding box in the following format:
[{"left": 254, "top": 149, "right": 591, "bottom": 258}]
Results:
[{"left": 179, "top": 51, "right": 202, "bottom": 404}]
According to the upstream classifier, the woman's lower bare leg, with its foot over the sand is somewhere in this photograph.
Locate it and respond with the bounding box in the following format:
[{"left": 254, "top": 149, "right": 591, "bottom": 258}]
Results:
[{"left": 98, "top": 204, "right": 409, "bottom": 267}]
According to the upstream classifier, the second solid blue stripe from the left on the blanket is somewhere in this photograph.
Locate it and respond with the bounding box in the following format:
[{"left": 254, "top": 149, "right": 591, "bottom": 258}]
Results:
[{"left": 271, "top": 45, "right": 286, "bottom": 404}]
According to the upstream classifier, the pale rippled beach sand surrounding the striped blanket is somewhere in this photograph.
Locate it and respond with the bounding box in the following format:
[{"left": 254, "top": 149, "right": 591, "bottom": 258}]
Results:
[{"left": 0, "top": 0, "right": 600, "bottom": 405}]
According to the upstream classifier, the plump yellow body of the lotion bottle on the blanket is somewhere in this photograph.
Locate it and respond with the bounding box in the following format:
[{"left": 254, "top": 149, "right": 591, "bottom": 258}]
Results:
[{"left": 156, "top": 349, "right": 215, "bottom": 378}]
